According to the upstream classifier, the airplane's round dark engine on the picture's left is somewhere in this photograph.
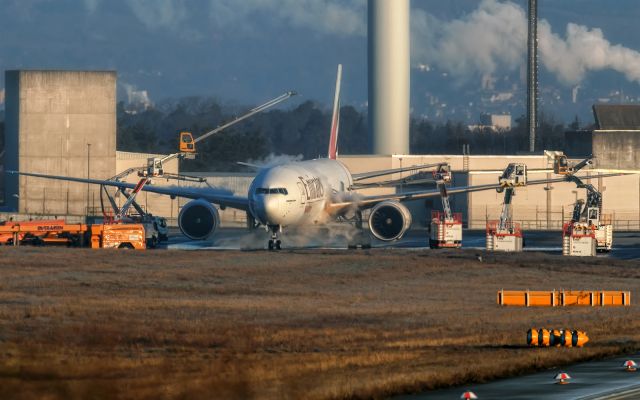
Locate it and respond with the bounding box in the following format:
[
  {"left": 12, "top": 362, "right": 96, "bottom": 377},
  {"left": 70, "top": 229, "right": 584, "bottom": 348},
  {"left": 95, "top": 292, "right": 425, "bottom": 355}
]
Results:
[{"left": 178, "top": 199, "right": 220, "bottom": 240}]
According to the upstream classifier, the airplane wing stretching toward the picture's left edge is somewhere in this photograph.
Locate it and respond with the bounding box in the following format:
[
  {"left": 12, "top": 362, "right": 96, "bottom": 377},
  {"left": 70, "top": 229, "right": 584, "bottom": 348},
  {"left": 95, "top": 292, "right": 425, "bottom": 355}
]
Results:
[{"left": 7, "top": 171, "right": 249, "bottom": 211}]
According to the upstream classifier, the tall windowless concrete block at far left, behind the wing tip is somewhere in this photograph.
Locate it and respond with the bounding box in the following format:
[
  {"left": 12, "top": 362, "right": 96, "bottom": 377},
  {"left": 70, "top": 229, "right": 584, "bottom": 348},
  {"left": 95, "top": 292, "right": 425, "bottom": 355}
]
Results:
[{"left": 5, "top": 71, "right": 116, "bottom": 215}]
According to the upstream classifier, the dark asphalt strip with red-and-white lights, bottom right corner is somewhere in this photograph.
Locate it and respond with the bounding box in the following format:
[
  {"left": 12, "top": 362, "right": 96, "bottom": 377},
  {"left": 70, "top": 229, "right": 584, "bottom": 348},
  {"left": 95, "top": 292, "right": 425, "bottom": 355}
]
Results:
[{"left": 394, "top": 349, "right": 640, "bottom": 400}]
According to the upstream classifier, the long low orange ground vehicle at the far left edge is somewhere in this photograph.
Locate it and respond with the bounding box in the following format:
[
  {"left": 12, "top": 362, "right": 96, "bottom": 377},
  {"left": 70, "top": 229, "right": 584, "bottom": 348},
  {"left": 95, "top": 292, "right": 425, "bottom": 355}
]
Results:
[{"left": 0, "top": 220, "right": 146, "bottom": 249}]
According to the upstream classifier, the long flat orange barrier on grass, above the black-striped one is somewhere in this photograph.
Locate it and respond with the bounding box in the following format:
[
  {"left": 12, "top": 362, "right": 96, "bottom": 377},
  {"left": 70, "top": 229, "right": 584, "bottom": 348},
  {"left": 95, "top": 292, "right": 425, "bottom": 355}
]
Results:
[{"left": 497, "top": 290, "right": 631, "bottom": 307}]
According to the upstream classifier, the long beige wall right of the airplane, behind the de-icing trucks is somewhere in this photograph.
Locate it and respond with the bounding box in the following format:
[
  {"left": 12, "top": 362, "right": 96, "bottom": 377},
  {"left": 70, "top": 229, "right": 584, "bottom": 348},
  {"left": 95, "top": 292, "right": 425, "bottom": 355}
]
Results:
[{"left": 340, "top": 155, "right": 640, "bottom": 229}]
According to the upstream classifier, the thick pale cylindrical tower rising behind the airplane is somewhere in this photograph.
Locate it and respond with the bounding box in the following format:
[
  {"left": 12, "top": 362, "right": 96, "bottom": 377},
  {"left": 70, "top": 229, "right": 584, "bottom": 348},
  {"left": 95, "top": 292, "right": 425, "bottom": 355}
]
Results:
[{"left": 368, "top": 0, "right": 410, "bottom": 154}]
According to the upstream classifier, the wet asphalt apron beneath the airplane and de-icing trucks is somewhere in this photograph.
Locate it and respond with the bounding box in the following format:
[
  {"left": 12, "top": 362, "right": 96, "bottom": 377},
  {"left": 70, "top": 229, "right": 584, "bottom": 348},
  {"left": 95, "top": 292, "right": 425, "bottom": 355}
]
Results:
[{"left": 160, "top": 226, "right": 640, "bottom": 260}]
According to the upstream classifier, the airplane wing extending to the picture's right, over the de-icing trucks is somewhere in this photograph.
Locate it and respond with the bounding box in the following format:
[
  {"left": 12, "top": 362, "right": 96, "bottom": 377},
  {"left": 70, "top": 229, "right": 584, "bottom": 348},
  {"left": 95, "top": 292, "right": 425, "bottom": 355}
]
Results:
[{"left": 327, "top": 173, "right": 627, "bottom": 215}]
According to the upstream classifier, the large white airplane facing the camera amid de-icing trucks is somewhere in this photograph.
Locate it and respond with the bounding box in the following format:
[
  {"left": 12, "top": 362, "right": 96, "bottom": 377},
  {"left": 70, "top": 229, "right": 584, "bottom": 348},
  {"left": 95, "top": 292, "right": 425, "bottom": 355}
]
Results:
[{"left": 8, "top": 65, "right": 624, "bottom": 250}]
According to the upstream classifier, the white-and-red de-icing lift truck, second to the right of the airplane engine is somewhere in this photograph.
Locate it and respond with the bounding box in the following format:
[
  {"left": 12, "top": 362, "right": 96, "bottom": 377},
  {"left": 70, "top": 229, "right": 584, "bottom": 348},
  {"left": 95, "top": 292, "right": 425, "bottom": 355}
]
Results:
[{"left": 486, "top": 163, "right": 527, "bottom": 251}]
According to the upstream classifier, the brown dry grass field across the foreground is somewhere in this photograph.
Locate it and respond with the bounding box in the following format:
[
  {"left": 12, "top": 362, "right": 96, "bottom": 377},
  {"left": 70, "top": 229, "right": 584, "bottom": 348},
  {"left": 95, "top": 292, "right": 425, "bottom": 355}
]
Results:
[{"left": 0, "top": 247, "right": 640, "bottom": 399}]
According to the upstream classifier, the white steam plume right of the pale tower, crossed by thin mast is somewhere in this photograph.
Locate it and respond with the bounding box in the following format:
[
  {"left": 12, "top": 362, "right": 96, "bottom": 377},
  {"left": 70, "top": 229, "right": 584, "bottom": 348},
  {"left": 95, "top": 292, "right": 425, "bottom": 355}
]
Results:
[{"left": 412, "top": 0, "right": 640, "bottom": 85}]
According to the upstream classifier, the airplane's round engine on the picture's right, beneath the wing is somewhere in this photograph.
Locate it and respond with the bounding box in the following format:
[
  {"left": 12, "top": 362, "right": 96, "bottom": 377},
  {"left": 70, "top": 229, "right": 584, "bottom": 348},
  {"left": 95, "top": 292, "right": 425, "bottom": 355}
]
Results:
[{"left": 369, "top": 200, "right": 411, "bottom": 242}]
